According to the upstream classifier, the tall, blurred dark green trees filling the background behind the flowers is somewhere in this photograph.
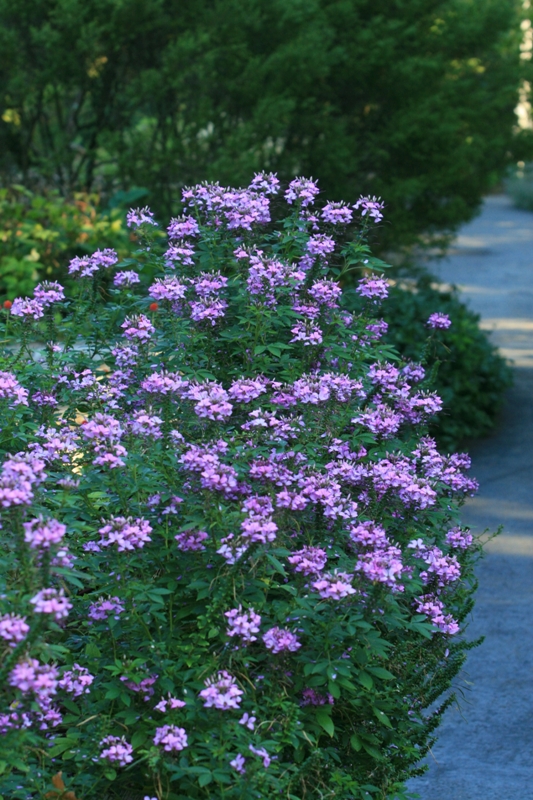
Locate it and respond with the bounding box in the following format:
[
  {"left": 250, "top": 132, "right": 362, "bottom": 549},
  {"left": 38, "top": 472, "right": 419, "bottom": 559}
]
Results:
[{"left": 0, "top": 0, "right": 523, "bottom": 248}]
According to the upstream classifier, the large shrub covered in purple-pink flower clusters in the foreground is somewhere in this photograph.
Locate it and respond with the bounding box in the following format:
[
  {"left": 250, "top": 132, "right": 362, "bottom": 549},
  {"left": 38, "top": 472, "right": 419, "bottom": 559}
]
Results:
[{"left": 0, "top": 174, "right": 477, "bottom": 800}]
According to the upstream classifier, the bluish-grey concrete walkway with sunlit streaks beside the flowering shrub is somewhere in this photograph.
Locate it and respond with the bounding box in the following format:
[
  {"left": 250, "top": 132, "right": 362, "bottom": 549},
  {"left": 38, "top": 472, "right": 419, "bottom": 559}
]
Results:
[{"left": 409, "top": 196, "right": 533, "bottom": 800}]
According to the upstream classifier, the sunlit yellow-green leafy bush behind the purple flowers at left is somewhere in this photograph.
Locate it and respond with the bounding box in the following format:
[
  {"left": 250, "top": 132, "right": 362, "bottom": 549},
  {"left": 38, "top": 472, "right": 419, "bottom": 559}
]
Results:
[{"left": 0, "top": 185, "right": 129, "bottom": 299}]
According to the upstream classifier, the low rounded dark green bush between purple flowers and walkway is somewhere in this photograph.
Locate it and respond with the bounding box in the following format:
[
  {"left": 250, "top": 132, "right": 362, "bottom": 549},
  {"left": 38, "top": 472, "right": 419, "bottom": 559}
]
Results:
[{"left": 383, "top": 275, "right": 512, "bottom": 448}]
